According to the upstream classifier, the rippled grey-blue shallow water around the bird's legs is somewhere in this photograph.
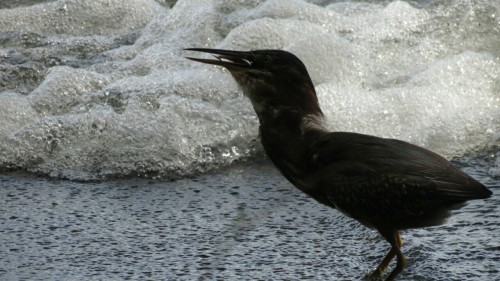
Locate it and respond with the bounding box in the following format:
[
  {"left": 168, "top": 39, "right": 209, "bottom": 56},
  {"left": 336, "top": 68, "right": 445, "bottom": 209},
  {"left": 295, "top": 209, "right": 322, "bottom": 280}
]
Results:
[{"left": 0, "top": 157, "right": 500, "bottom": 281}]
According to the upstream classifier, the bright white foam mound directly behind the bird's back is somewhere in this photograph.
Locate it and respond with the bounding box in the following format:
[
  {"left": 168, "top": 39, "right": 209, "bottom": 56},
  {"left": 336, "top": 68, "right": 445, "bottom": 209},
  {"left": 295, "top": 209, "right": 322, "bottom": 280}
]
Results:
[{"left": 317, "top": 52, "right": 500, "bottom": 156}]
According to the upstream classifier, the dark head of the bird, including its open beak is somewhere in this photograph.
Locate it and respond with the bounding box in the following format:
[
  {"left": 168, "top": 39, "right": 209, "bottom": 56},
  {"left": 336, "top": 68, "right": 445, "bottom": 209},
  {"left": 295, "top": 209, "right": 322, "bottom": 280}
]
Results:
[{"left": 186, "top": 48, "right": 323, "bottom": 116}]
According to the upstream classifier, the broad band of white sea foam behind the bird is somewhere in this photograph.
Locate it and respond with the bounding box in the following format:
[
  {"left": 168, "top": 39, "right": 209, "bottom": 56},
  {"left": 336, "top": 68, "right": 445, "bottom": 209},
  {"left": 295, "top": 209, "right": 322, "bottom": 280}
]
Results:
[{"left": 0, "top": 0, "right": 500, "bottom": 180}]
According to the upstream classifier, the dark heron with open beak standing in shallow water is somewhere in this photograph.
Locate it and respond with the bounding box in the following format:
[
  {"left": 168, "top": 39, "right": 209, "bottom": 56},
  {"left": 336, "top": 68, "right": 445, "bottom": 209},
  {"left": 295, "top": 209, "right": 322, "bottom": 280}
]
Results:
[{"left": 186, "top": 48, "right": 492, "bottom": 280}]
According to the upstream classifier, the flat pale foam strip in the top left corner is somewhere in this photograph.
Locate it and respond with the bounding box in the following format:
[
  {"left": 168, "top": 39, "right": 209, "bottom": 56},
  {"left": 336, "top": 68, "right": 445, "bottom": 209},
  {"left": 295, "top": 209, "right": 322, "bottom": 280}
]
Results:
[{"left": 0, "top": 0, "right": 159, "bottom": 36}]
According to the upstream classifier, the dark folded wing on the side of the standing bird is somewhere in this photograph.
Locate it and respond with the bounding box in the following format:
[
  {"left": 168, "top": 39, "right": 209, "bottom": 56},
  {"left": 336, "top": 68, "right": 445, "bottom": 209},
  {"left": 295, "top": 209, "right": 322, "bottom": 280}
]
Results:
[{"left": 302, "top": 132, "right": 491, "bottom": 225}]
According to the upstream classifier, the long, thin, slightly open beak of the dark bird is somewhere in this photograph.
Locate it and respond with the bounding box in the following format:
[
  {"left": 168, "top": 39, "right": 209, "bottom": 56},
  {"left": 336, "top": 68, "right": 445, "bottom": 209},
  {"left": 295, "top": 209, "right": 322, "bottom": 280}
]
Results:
[{"left": 184, "top": 48, "right": 253, "bottom": 69}]
